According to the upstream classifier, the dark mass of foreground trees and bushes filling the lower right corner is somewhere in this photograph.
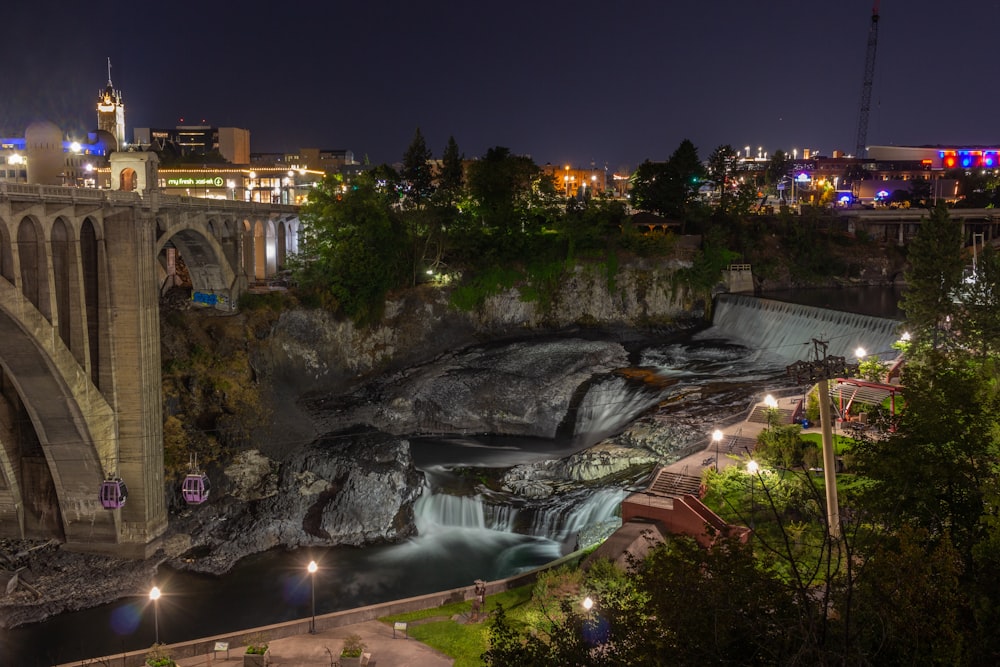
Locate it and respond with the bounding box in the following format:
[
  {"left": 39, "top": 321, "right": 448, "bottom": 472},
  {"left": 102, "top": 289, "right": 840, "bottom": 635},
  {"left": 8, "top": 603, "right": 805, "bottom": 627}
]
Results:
[{"left": 470, "top": 209, "right": 1000, "bottom": 665}]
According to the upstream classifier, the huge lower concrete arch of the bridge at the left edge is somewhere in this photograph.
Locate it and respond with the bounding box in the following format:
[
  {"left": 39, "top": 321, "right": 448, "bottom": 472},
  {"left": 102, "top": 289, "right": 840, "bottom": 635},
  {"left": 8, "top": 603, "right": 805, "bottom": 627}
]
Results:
[{"left": 0, "top": 282, "right": 122, "bottom": 545}]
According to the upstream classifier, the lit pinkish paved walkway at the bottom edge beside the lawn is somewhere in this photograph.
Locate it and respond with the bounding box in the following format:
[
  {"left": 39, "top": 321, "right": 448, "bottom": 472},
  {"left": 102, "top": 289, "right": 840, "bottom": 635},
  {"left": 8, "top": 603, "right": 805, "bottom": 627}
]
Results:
[{"left": 177, "top": 621, "right": 454, "bottom": 667}]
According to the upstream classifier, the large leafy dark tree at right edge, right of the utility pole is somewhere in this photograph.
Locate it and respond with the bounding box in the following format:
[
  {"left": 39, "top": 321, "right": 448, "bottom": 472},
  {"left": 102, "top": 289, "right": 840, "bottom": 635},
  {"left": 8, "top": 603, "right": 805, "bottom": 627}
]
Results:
[{"left": 852, "top": 348, "right": 1000, "bottom": 563}]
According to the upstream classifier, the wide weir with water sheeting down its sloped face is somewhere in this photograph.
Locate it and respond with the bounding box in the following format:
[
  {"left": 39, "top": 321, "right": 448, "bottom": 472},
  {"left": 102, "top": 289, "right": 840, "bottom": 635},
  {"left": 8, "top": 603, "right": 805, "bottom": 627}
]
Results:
[{"left": 710, "top": 294, "right": 901, "bottom": 364}]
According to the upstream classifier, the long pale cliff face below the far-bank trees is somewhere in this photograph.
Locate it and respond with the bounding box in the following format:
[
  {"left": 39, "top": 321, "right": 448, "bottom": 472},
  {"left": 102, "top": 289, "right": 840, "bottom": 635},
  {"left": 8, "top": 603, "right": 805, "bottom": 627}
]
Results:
[{"left": 253, "top": 260, "right": 690, "bottom": 392}]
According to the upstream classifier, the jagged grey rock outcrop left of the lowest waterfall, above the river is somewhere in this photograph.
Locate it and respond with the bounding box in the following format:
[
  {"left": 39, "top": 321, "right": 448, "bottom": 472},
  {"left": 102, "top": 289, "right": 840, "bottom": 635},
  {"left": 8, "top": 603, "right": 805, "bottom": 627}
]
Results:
[{"left": 168, "top": 432, "right": 423, "bottom": 573}]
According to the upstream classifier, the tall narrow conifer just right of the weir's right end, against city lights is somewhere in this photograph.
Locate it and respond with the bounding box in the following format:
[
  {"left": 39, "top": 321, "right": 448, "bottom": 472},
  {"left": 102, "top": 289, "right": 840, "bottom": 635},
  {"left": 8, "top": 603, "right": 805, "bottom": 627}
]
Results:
[{"left": 900, "top": 202, "right": 964, "bottom": 347}]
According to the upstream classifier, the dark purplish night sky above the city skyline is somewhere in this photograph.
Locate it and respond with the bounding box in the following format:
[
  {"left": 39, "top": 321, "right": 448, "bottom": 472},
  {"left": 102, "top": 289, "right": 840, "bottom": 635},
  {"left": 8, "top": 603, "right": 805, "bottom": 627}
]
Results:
[{"left": 0, "top": 0, "right": 1000, "bottom": 169}]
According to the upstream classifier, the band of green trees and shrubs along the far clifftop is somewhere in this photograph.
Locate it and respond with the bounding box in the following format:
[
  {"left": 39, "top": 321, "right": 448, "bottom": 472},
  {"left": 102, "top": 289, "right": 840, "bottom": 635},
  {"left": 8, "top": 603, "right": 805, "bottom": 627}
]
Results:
[{"left": 288, "top": 130, "right": 899, "bottom": 324}]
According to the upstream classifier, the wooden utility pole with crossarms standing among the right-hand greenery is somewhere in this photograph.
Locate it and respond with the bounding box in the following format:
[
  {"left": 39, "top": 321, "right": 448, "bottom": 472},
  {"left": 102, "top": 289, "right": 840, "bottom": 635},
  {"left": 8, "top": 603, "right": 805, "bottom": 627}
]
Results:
[{"left": 787, "top": 338, "right": 858, "bottom": 538}]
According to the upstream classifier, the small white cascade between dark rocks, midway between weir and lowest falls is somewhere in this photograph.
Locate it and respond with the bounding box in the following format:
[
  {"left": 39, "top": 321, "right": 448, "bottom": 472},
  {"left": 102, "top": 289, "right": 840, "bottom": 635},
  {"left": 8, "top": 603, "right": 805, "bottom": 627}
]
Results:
[{"left": 573, "top": 376, "right": 659, "bottom": 444}]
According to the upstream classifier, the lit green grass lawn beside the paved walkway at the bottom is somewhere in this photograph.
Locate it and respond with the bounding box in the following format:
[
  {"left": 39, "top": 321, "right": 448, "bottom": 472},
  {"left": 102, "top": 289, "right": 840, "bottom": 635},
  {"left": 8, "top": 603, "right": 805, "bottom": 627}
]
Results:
[{"left": 379, "top": 585, "right": 534, "bottom": 667}]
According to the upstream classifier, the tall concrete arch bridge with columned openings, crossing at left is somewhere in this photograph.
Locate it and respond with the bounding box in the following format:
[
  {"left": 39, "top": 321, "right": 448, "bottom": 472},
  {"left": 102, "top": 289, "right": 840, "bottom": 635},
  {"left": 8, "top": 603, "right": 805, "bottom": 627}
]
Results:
[{"left": 0, "top": 177, "right": 299, "bottom": 557}]
